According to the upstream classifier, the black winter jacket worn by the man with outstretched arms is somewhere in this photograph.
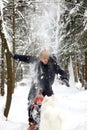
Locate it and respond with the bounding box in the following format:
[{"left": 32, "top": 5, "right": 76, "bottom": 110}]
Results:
[{"left": 13, "top": 54, "right": 67, "bottom": 96}]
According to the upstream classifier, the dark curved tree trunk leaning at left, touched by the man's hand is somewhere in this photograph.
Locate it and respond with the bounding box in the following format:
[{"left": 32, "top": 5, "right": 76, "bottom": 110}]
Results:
[{"left": 0, "top": 21, "right": 13, "bottom": 117}]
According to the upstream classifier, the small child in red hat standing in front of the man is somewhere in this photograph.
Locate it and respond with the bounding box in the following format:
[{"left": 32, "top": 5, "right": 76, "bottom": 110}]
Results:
[{"left": 28, "top": 92, "right": 43, "bottom": 130}]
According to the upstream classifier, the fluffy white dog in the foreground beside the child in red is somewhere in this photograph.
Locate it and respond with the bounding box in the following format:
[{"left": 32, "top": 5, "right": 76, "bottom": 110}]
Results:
[{"left": 40, "top": 96, "right": 62, "bottom": 130}]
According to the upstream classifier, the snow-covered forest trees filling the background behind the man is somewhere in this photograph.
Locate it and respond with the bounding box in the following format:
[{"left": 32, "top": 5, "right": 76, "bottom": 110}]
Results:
[{"left": 0, "top": 0, "right": 87, "bottom": 117}]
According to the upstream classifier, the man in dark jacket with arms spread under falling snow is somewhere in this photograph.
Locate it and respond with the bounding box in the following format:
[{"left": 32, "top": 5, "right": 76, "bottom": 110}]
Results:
[{"left": 11, "top": 49, "right": 69, "bottom": 115}]
